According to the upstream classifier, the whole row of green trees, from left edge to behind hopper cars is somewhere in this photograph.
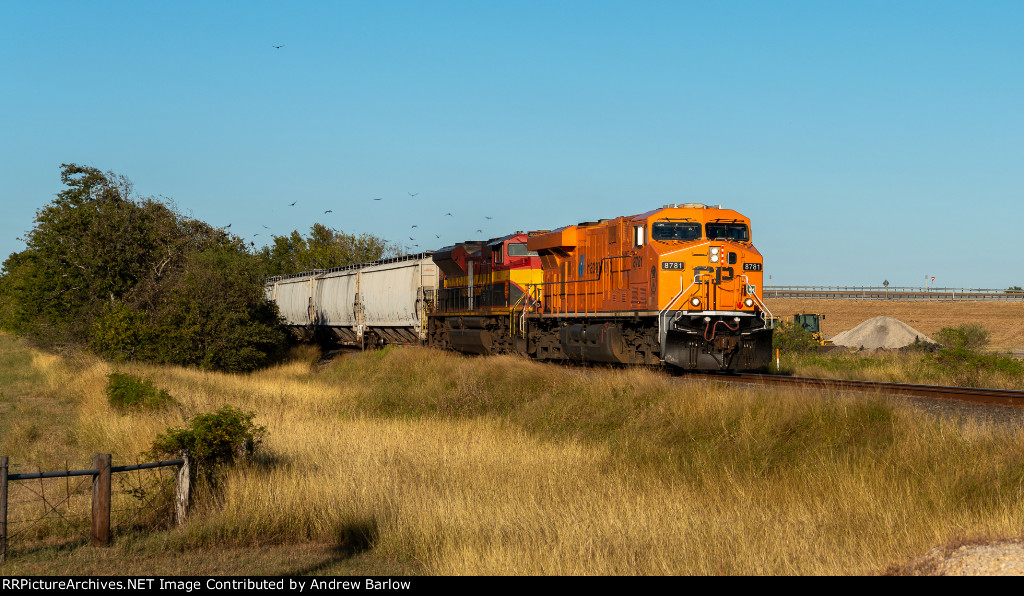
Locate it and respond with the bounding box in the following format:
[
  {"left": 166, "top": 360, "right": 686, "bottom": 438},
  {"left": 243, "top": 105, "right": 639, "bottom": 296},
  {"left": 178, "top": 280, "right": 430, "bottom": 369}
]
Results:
[{"left": 0, "top": 164, "right": 397, "bottom": 372}]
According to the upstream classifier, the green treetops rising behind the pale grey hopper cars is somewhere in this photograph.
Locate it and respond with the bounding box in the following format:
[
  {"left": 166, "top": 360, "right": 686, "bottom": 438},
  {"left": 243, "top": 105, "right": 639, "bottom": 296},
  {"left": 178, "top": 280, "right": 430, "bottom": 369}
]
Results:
[{"left": 260, "top": 223, "right": 398, "bottom": 275}]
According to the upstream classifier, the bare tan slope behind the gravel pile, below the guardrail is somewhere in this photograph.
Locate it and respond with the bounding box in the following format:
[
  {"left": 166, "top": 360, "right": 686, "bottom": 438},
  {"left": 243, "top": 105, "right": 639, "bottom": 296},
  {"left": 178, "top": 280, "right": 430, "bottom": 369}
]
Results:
[{"left": 765, "top": 298, "right": 1024, "bottom": 354}]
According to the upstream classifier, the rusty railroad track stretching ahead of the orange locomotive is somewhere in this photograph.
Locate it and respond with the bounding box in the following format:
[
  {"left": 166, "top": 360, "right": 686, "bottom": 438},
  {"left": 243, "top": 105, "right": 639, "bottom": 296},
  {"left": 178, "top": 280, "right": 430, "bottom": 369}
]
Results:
[{"left": 680, "top": 372, "right": 1024, "bottom": 408}]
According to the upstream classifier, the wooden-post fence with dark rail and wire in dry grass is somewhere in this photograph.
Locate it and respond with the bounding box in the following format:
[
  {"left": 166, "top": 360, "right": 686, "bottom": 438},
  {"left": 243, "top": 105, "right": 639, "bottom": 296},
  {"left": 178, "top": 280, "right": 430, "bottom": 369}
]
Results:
[{"left": 0, "top": 454, "right": 194, "bottom": 562}]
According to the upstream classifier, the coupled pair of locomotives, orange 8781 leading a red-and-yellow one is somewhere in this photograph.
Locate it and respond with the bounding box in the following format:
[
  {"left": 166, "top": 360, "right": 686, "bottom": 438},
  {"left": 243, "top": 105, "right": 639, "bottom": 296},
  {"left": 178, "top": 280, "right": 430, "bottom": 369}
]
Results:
[{"left": 429, "top": 204, "right": 772, "bottom": 371}]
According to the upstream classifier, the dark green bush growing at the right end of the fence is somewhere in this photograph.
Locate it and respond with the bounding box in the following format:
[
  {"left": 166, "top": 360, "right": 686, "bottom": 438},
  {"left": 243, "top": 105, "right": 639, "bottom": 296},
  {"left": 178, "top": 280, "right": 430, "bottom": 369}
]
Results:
[{"left": 151, "top": 406, "right": 266, "bottom": 474}]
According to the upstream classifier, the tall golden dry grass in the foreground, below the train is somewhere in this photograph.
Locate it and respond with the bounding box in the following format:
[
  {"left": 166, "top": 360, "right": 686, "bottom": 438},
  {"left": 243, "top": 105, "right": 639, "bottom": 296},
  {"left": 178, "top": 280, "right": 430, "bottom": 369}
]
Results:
[{"left": 0, "top": 336, "right": 1024, "bottom": 574}]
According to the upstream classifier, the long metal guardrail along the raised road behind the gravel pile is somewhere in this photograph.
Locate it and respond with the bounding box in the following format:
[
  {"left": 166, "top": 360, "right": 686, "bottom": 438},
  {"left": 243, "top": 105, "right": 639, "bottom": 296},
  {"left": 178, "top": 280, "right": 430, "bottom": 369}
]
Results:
[{"left": 764, "top": 286, "right": 1024, "bottom": 302}]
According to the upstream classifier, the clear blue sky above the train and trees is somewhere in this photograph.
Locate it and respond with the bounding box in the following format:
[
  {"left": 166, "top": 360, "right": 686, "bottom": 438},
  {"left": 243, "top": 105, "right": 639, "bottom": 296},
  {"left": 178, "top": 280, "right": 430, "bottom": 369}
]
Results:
[{"left": 0, "top": 0, "right": 1024, "bottom": 288}]
